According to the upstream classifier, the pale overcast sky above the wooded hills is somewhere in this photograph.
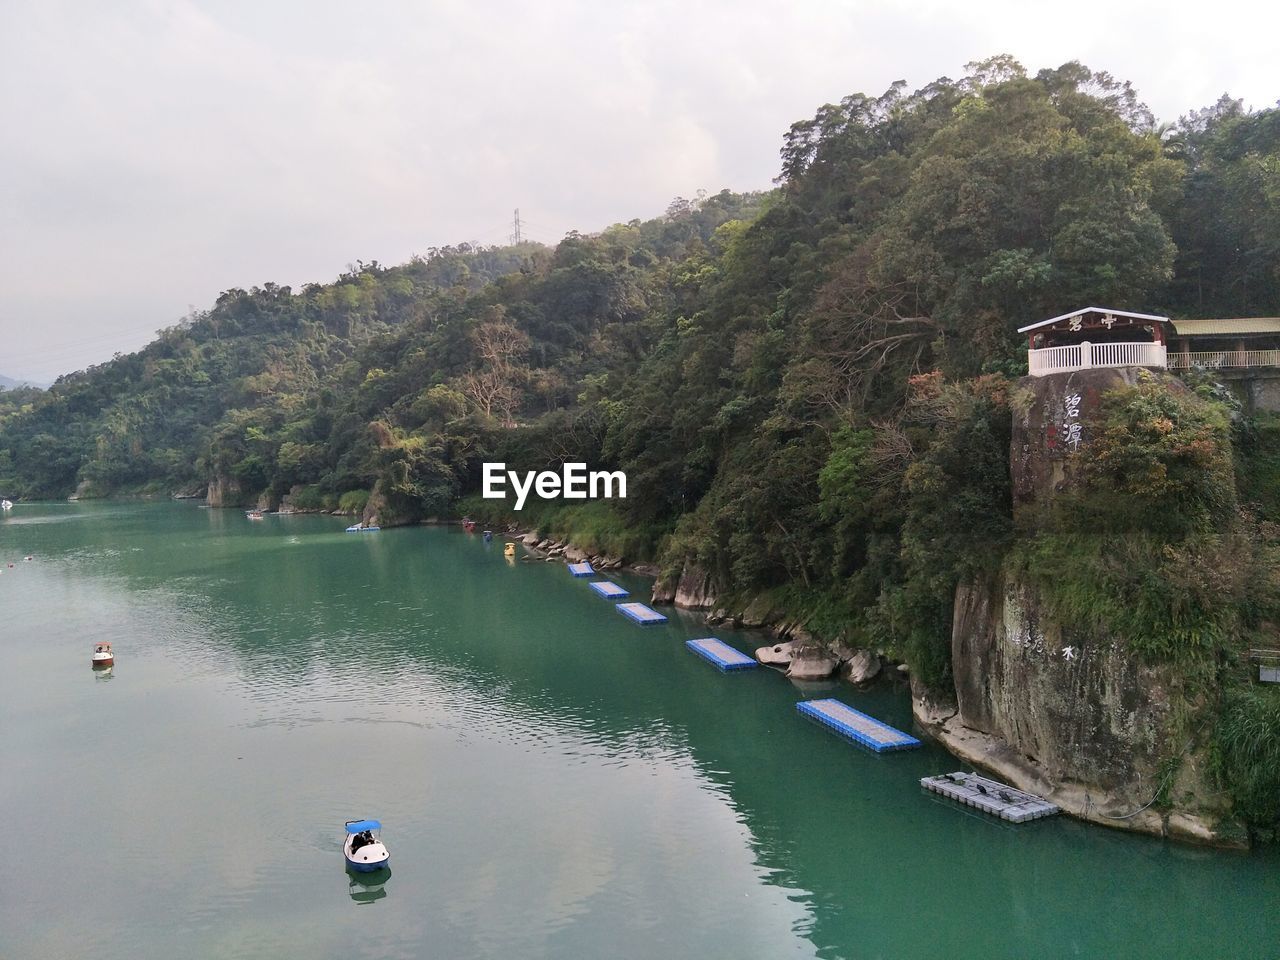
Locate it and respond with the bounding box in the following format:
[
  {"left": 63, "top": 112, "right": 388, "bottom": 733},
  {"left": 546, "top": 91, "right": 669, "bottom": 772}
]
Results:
[{"left": 0, "top": 0, "right": 1280, "bottom": 381}]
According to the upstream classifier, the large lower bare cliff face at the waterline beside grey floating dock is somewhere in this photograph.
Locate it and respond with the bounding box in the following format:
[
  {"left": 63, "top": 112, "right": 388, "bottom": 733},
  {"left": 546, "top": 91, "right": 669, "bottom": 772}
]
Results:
[{"left": 916, "top": 580, "right": 1225, "bottom": 841}]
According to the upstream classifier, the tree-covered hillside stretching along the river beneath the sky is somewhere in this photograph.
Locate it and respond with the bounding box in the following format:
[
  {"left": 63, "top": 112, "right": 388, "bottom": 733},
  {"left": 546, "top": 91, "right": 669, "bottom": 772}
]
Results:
[{"left": 0, "top": 58, "right": 1280, "bottom": 834}]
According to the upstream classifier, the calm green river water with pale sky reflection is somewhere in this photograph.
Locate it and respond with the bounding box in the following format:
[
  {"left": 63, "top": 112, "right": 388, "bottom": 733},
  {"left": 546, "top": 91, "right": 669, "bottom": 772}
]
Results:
[{"left": 0, "top": 504, "right": 1280, "bottom": 960}]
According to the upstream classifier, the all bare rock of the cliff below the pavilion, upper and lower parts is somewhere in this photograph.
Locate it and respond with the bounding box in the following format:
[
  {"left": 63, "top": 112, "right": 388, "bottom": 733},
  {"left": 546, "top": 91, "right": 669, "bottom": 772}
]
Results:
[{"left": 913, "top": 369, "right": 1225, "bottom": 842}]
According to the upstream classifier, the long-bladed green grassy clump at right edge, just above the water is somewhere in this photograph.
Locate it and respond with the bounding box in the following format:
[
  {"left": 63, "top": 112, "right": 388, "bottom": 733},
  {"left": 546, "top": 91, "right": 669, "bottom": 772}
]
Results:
[{"left": 1213, "top": 686, "right": 1280, "bottom": 831}]
